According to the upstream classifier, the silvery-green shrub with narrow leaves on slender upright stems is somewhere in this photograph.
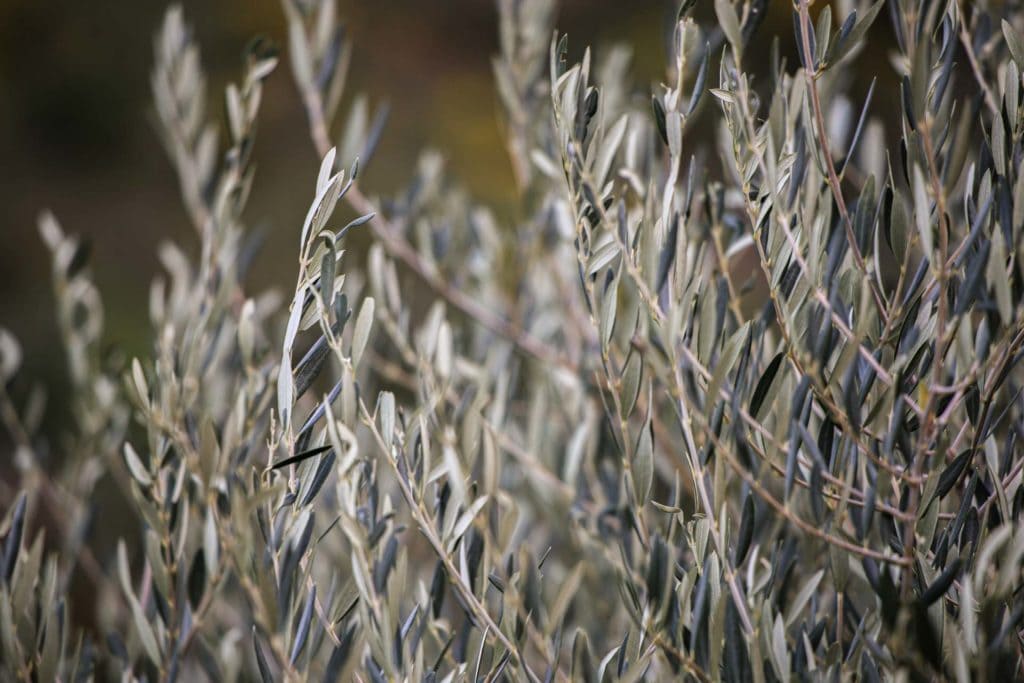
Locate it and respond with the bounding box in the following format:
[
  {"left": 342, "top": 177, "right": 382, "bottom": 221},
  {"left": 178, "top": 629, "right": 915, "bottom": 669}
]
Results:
[{"left": 0, "top": 0, "right": 1024, "bottom": 681}]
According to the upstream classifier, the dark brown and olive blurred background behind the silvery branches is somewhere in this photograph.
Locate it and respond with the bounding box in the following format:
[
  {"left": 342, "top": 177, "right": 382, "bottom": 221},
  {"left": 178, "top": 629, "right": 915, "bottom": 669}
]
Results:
[{"left": 0, "top": 0, "right": 880, "bottom": 426}]
